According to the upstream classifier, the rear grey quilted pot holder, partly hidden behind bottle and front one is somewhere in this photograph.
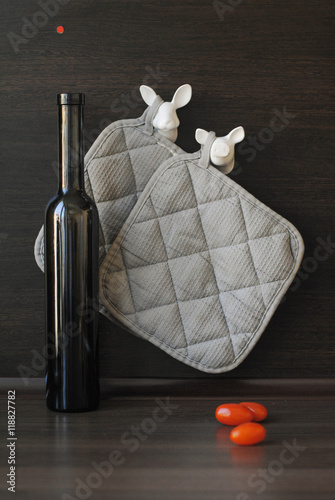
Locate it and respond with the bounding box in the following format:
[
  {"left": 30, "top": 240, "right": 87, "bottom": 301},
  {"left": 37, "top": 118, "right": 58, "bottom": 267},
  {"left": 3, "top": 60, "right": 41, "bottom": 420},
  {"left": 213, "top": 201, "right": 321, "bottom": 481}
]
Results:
[{"left": 34, "top": 96, "right": 185, "bottom": 271}]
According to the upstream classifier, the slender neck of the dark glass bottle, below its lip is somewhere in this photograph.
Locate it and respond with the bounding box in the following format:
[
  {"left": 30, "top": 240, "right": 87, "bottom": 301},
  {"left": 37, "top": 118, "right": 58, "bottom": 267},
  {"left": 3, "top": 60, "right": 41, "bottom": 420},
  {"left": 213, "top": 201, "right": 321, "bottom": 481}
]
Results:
[{"left": 58, "top": 104, "right": 84, "bottom": 193}]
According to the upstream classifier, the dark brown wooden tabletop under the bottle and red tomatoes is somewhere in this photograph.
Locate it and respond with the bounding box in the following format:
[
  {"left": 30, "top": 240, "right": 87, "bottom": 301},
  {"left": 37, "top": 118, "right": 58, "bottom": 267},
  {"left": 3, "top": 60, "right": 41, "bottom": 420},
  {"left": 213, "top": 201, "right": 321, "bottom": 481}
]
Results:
[{"left": 0, "top": 379, "right": 335, "bottom": 500}]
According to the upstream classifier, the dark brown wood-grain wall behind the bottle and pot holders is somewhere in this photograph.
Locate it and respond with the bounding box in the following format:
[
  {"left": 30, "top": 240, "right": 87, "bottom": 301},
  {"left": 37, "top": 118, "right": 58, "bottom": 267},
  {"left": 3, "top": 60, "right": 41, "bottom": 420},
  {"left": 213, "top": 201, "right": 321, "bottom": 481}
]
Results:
[{"left": 0, "top": 0, "right": 335, "bottom": 378}]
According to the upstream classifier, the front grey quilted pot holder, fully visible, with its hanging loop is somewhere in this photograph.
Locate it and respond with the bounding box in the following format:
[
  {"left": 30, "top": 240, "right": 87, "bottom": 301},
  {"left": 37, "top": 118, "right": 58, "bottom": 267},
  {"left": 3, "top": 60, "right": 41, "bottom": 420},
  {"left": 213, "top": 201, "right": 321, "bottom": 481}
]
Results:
[{"left": 100, "top": 132, "right": 304, "bottom": 373}]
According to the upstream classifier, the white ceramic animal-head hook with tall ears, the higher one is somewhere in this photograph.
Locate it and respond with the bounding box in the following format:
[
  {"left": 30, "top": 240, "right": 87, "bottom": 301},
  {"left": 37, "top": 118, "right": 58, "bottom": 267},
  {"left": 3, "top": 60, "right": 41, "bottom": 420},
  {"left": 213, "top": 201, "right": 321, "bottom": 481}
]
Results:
[{"left": 140, "top": 83, "right": 192, "bottom": 142}]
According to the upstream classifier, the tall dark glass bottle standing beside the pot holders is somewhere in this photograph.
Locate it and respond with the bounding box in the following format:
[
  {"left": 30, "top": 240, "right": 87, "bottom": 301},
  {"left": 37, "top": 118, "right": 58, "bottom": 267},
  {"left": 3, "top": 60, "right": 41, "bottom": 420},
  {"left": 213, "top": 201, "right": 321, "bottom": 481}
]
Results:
[{"left": 44, "top": 93, "right": 99, "bottom": 412}]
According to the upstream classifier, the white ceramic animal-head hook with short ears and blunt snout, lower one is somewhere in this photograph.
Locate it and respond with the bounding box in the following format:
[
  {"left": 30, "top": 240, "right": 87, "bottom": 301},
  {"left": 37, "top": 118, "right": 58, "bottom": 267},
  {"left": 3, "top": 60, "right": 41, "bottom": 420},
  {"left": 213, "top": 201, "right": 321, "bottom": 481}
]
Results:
[{"left": 195, "top": 127, "right": 245, "bottom": 174}]
